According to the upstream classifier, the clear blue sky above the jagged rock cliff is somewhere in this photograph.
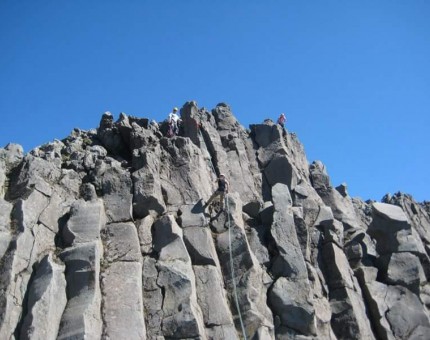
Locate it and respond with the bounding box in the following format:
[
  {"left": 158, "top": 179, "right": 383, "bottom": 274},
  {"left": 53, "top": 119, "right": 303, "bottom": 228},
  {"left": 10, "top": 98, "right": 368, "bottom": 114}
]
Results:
[{"left": 0, "top": 0, "right": 430, "bottom": 201}]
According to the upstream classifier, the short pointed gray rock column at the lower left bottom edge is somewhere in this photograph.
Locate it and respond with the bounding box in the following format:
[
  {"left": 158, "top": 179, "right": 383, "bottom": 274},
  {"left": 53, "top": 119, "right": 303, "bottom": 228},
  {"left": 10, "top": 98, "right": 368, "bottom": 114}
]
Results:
[{"left": 20, "top": 254, "right": 67, "bottom": 340}]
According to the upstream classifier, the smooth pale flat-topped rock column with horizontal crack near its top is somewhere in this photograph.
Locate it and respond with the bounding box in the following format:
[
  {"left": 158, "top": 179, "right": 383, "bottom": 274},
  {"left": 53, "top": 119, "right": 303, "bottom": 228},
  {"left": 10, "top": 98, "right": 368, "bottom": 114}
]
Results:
[{"left": 102, "top": 223, "right": 146, "bottom": 339}]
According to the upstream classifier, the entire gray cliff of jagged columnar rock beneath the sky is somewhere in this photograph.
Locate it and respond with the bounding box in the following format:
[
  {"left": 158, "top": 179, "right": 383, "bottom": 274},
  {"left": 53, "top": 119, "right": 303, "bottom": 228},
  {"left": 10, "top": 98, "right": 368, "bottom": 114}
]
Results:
[{"left": 0, "top": 102, "right": 430, "bottom": 340}]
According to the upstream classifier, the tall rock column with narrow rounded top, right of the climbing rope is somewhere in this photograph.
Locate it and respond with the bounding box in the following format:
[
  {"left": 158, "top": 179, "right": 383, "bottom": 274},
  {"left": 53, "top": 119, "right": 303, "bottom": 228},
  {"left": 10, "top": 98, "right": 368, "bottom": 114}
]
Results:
[{"left": 269, "top": 183, "right": 316, "bottom": 336}]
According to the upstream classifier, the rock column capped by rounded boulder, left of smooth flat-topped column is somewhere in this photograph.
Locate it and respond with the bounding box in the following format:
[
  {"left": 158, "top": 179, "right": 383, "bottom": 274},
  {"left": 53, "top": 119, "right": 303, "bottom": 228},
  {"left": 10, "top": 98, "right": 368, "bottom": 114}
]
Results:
[{"left": 58, "top": 199, "right": 106, "bottom": 339}]
